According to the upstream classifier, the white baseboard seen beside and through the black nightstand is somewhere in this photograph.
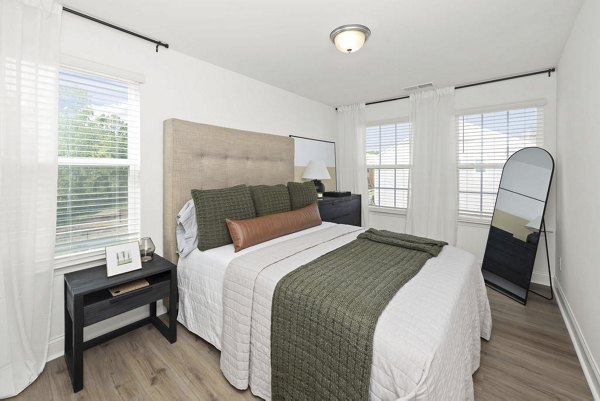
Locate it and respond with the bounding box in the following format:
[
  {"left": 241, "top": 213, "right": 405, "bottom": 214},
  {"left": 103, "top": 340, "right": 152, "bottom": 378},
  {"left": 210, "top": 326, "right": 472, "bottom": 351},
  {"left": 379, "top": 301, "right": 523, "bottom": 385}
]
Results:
[{"left": 47, "top": 301, "right": 167, "bottom": 362}]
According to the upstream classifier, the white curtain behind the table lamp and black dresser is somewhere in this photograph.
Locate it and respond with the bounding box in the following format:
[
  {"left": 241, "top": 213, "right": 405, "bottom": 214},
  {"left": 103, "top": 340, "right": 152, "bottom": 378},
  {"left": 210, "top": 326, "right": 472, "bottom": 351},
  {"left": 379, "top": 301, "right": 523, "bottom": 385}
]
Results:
[{"left": 336, "top": 103, "right": 369, "bottom": 227}]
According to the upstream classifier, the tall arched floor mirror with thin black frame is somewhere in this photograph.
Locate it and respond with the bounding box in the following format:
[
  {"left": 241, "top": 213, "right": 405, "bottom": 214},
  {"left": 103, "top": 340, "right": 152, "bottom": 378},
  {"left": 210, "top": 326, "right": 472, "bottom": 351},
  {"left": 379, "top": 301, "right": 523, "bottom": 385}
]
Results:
[{"left": 481, "top": 147, "right": 554, "bottom": 304}]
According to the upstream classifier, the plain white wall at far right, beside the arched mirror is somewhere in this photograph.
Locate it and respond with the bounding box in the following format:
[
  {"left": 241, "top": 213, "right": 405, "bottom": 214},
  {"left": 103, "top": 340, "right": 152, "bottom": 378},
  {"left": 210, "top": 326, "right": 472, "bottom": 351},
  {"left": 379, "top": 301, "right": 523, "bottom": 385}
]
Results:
[{"left": 557, "top": 0, "right": 600, "bottom": 399}]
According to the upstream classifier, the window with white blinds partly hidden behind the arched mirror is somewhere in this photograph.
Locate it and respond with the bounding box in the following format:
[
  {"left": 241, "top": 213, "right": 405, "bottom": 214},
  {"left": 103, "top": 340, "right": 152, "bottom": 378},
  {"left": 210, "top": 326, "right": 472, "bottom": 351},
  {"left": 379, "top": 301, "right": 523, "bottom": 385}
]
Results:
[{"left": 457, "top": 107, "right": 544, "bottom": 218}]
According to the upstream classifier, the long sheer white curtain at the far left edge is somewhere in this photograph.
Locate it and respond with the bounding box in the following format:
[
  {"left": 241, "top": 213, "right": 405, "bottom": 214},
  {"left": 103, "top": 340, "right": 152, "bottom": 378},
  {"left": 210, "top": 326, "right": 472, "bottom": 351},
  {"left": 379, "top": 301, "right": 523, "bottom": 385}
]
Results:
[{"left": 0, "top": 0, "right": 62, "bottom": 398}]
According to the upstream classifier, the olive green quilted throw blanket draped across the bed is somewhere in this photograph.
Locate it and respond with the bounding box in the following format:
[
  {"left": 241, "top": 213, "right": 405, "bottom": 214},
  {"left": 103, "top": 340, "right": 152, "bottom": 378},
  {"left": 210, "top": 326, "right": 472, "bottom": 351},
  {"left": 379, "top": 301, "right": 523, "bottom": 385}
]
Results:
[{"left": 271, "top": 229, "right": 446, "bottom": 400}]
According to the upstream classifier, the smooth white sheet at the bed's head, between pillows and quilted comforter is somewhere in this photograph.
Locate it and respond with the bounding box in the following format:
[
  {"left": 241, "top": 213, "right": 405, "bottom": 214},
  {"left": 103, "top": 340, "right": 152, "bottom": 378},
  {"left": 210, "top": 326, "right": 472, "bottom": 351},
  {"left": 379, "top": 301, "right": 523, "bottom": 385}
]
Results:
[{"left": 177, "top": 222, "right": 335, "bottom": 350}]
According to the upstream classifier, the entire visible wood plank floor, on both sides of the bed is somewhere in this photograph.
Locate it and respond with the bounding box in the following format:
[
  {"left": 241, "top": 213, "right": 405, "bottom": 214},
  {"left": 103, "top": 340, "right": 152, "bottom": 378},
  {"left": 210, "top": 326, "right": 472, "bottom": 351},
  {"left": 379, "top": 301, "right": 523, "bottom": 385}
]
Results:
[{"left": 11, "top": 289, "right": 592, "bottom": 401}]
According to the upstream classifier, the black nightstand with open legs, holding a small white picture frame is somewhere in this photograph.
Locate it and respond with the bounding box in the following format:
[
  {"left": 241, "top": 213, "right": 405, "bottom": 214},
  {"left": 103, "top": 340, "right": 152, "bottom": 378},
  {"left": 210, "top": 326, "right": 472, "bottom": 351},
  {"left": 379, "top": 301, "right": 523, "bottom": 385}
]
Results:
[{"left": 65, "top": 254, "right": 177, "bottom": 392}]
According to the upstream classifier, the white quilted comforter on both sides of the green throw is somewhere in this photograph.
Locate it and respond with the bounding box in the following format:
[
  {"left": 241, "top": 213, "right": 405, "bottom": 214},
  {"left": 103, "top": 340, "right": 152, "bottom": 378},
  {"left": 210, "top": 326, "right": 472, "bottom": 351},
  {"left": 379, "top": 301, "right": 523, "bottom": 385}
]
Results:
[{"left": 221, "top": 225, "right": 491, "bottom": 400}]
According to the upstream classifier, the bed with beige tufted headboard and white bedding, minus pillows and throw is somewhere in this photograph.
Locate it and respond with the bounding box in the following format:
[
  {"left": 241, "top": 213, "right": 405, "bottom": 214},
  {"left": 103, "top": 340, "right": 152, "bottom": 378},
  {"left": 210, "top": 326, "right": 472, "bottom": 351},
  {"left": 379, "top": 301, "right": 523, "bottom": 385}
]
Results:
[{"left": 163, "top": 120, "right": 491, "bottom": 400}]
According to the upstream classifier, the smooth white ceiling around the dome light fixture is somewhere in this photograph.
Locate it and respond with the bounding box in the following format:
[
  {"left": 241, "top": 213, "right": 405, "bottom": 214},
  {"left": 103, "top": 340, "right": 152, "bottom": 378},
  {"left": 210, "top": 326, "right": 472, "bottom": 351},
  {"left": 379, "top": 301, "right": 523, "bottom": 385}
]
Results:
[{"left": 65, "top": 0, "right": 582, "bottom": 106}]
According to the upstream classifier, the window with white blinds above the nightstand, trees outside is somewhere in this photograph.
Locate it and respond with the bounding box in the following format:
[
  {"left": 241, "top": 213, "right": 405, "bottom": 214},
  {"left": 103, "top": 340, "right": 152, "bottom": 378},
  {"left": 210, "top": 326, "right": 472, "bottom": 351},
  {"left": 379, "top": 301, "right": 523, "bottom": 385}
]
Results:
[{"left": 55, "top": 69, "right": 140, "bottom": 256}]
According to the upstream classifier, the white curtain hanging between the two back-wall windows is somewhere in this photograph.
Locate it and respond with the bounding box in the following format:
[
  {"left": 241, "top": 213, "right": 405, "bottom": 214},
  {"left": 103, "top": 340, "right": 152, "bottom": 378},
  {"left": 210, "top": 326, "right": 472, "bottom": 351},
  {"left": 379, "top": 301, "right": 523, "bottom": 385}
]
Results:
[{"left": 406, "top": 88, "right": 458, "bottom": 245}]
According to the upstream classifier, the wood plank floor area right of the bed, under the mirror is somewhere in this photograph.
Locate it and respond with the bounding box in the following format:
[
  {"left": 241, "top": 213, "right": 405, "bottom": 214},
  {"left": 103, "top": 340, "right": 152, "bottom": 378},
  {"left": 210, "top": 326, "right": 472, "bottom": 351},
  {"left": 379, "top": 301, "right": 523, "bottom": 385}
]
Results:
[{"left": 473, "top": 285, "right": 593, "bottom": 401}]
